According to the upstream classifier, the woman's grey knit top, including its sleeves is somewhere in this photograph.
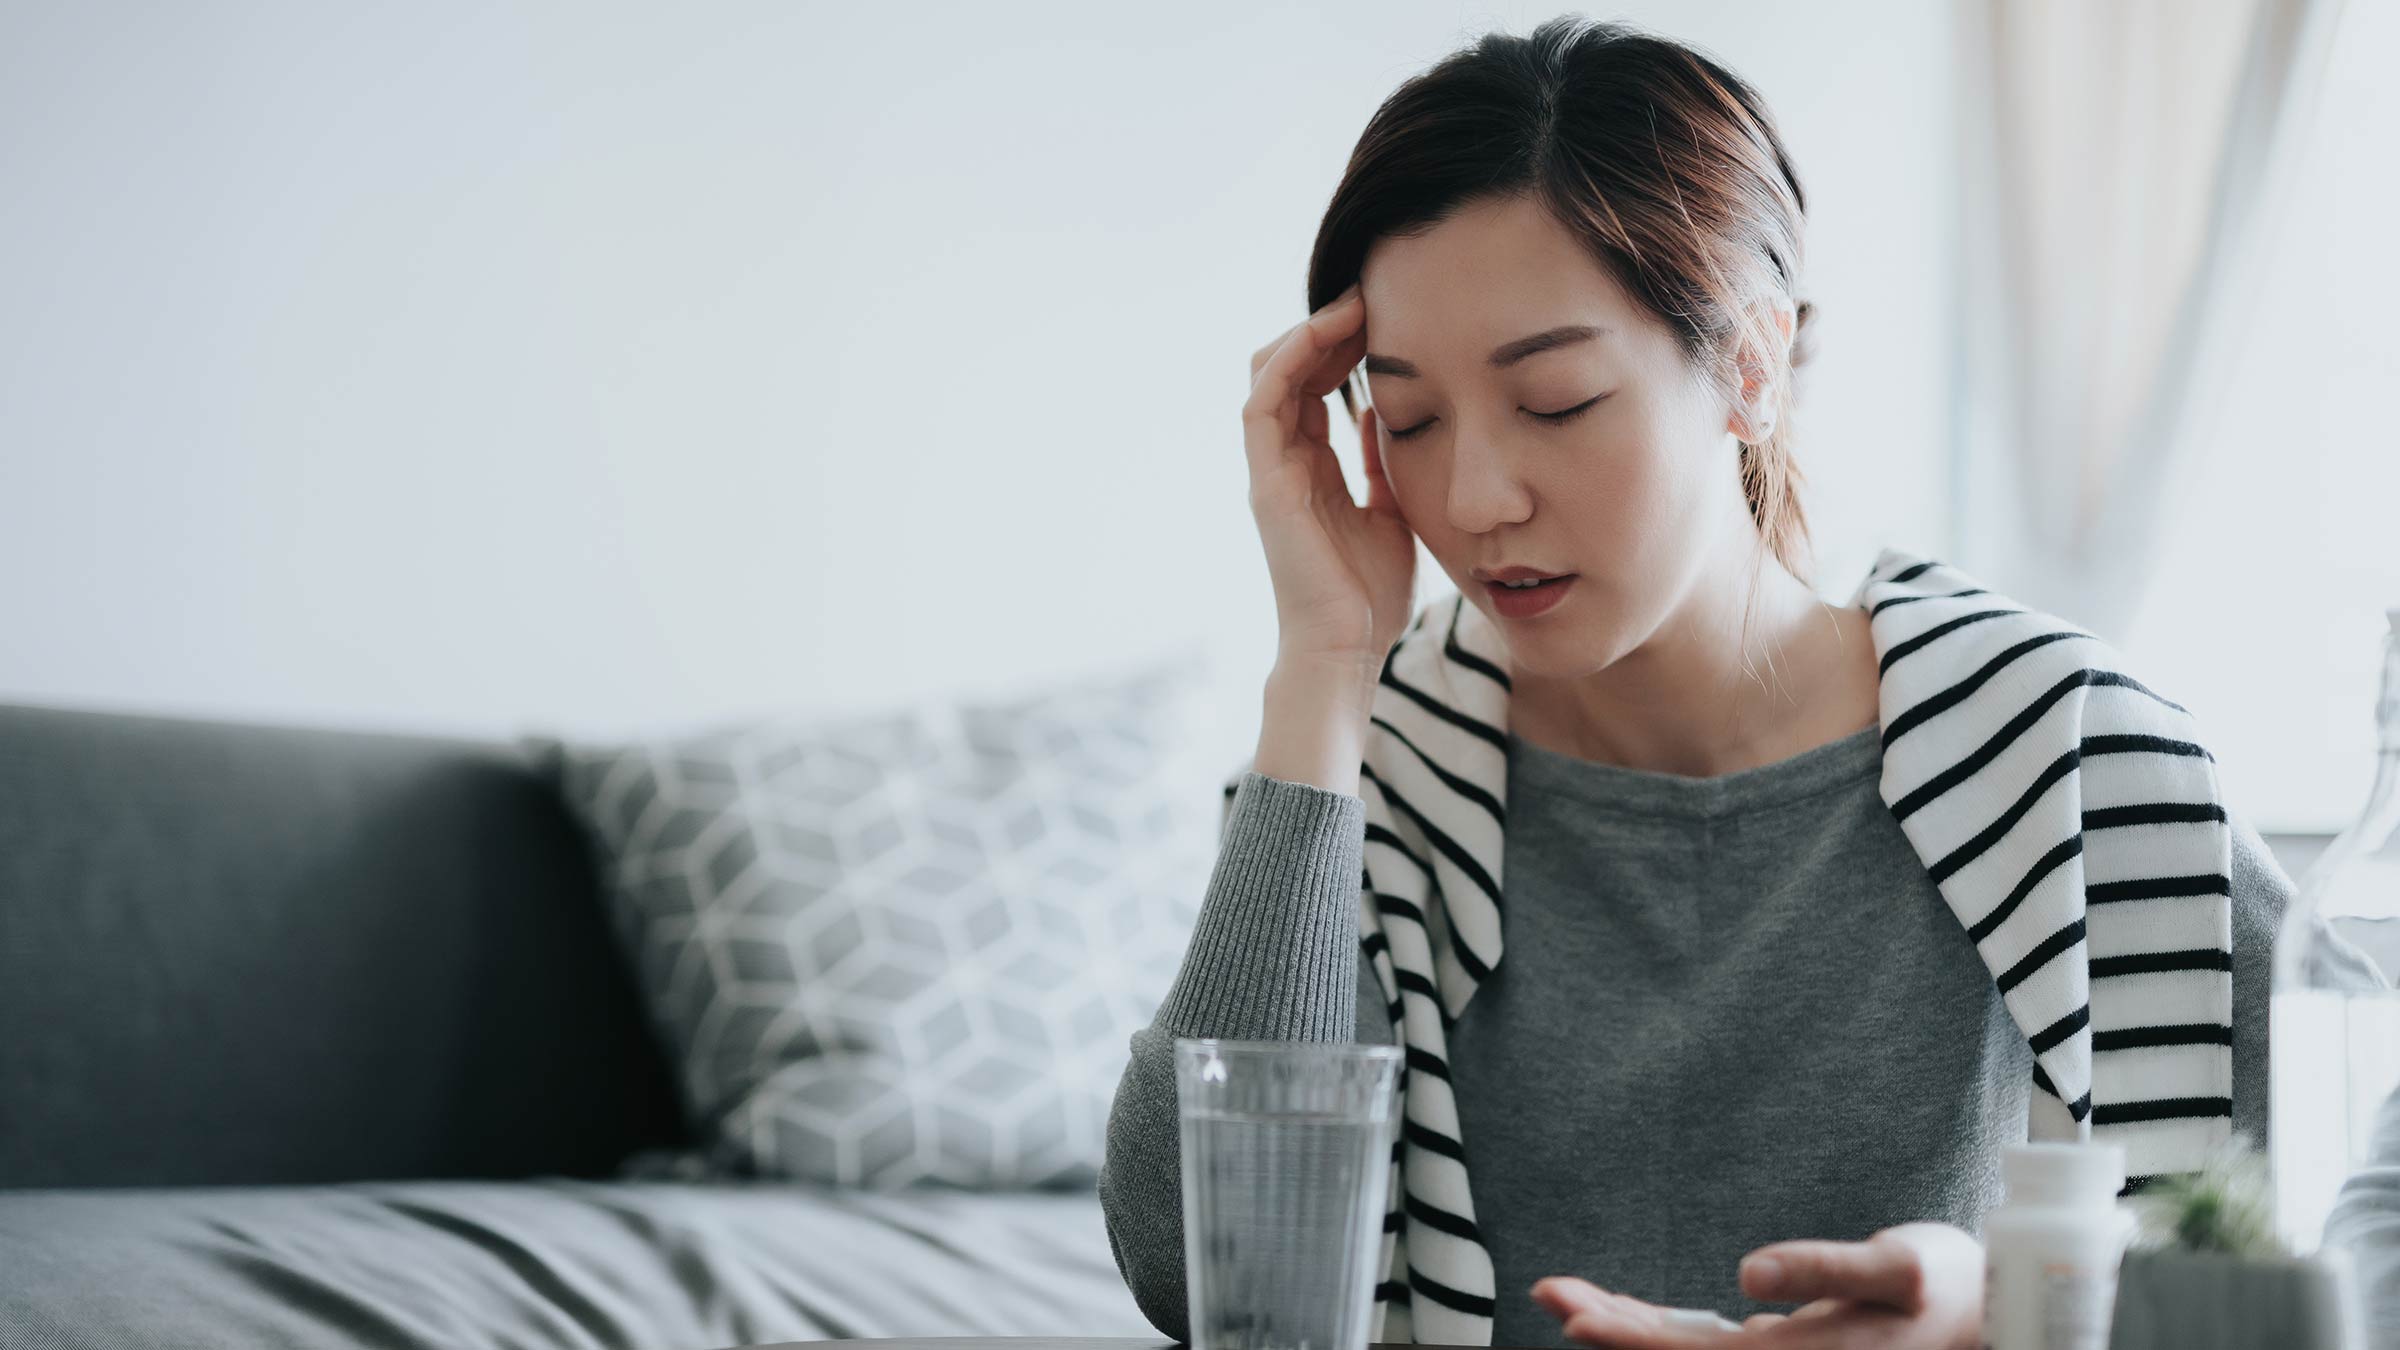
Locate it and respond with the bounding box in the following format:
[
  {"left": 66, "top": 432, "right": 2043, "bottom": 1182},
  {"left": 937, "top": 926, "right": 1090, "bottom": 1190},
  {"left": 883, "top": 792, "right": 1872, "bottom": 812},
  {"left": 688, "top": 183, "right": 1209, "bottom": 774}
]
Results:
[{"left": 1099, "top": 728, "right": 2292, "bottom": 1345}]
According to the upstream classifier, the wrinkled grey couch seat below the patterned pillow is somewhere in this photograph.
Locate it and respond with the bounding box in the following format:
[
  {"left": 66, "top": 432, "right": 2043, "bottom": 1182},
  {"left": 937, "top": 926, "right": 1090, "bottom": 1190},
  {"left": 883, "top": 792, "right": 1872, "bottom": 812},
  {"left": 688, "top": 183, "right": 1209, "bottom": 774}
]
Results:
[{"left": 0, "top": 1179, "right": 1154, "bottom": 1350}]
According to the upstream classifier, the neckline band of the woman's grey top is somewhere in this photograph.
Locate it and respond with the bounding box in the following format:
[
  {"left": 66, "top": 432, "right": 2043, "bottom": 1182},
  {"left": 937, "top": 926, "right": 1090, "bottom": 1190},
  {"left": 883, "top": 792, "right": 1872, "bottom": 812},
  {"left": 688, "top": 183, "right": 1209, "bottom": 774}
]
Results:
[{"left": 1507, "top": 725, "right": 1884, "bottom": 817}]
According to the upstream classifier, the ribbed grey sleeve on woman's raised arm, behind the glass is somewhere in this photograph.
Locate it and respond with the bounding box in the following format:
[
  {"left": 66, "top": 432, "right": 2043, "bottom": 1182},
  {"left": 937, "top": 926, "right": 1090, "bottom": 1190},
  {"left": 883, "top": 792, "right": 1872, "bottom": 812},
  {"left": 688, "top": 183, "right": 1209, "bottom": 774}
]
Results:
[{"left": 1099, "top": 771, "right": 1392, "bottom": 1340}]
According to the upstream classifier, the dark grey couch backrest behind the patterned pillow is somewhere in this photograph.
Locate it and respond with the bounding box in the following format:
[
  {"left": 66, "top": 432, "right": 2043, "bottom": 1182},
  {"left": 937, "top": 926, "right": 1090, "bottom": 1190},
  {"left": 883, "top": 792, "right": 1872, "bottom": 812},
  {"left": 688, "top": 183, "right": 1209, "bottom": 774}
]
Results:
[{"left": 0, "top": 706, "right": 679, "bottom": 1187}]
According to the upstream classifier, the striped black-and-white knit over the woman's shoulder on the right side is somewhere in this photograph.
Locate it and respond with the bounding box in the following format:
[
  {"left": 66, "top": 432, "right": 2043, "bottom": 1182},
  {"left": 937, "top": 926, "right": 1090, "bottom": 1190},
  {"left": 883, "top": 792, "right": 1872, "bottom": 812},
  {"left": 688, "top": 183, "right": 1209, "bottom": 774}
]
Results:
[{"left": 1853, "top": 550, "right": 2232, "bottom": 1177}]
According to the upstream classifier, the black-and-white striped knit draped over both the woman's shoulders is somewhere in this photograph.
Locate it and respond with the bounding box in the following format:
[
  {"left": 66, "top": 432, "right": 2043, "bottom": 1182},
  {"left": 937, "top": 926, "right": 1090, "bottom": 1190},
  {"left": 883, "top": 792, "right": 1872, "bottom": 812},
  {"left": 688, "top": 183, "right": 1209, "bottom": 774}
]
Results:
[{"left": 1226, "top": 550, "right": 2232, "bottom": 1345}]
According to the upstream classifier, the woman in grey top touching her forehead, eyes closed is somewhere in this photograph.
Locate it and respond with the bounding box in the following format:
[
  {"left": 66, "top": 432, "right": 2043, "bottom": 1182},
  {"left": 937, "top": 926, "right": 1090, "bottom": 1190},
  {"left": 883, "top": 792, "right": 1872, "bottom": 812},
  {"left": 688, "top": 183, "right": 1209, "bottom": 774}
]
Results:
[{"left": 1099, "top": 17, "right": 2290, "bottom": 1345}]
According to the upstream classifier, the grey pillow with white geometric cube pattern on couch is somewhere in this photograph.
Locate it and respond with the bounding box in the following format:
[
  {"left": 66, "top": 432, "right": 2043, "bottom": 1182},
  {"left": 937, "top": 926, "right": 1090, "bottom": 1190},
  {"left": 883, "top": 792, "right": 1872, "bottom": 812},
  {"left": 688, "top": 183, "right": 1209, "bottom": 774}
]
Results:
[{"left": 559, "top": 658, "right": 1222, "bottom": 1189}]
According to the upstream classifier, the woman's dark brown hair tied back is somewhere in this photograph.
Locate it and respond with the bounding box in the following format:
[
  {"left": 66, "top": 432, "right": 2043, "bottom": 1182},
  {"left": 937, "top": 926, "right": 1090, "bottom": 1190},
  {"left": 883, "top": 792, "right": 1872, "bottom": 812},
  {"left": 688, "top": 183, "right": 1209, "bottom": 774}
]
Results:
[{"left": 1308, "top": 14, "right": 1814, "bottom": 579}]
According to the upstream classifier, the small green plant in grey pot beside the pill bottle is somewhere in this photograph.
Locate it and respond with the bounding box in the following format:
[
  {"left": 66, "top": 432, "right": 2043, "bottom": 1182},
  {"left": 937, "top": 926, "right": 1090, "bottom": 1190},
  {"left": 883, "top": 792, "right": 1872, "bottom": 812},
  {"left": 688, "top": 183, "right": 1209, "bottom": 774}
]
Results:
[{"left": 2110, "top": 1134, "right": 2362, "bottom": 1350}]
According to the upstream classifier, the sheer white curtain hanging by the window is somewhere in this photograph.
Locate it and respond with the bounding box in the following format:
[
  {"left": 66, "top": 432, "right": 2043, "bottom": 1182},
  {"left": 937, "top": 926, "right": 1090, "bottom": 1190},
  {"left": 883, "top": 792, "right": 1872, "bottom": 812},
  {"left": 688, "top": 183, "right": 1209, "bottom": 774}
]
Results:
[{"left": 1949, "top": 0, "right": 2342, "bottom": 637}]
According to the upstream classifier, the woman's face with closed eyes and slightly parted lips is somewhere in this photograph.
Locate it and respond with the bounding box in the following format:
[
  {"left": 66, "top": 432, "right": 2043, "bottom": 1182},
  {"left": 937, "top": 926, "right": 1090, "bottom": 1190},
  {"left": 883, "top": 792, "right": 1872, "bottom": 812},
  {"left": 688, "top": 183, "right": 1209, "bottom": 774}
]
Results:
[{"left": 1361, "top": 199, "right": 1750, "bottom": 677}]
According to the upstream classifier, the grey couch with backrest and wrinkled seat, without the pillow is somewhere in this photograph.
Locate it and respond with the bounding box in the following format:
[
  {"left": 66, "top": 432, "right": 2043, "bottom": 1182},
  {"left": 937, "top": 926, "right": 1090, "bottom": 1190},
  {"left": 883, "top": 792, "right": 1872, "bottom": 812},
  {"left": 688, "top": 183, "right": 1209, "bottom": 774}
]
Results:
[{"left": 0, "top": 706, "right": 1154, "bottom": 1350}]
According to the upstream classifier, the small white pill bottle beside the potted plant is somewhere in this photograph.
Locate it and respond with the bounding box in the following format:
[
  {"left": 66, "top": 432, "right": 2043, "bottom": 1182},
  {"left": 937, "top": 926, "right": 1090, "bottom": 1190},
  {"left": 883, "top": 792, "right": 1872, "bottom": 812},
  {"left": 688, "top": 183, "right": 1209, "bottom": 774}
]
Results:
[{"left": 1982, "top": 1143, "right": 2134, "bottom": 1350}]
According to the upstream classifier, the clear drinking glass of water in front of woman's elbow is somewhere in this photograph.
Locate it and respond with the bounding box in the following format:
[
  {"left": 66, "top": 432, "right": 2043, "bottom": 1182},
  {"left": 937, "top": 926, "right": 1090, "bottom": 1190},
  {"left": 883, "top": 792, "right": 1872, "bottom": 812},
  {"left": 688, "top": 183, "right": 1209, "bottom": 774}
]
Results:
[{"left": 1176, "top": 1035, "right": 1402, "bottom": 1350}]
